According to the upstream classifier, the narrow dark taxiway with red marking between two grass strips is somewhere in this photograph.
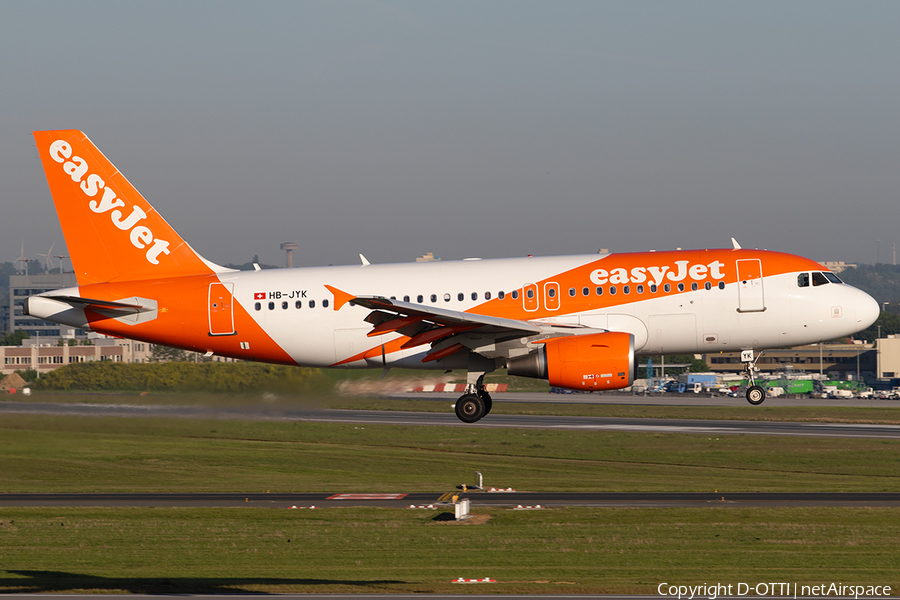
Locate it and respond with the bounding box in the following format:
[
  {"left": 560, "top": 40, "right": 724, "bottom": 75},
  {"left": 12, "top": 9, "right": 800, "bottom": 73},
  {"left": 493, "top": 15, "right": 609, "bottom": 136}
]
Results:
[{"left": 0, "top": 490, "right": 900, "bottom": 510}]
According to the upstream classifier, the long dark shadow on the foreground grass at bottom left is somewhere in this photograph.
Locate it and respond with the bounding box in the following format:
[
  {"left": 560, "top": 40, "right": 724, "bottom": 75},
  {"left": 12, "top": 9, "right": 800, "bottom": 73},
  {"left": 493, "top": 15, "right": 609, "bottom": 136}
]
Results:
[{"left": 0, "top": 571, "right": 410, "bottom": 595}]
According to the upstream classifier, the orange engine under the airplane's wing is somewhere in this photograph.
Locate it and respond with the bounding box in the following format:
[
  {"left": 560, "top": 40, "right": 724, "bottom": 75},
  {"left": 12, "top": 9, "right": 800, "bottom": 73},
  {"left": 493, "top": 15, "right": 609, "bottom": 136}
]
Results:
[{"left": 507, "top": 331, "right": 634, "bottom": 390}]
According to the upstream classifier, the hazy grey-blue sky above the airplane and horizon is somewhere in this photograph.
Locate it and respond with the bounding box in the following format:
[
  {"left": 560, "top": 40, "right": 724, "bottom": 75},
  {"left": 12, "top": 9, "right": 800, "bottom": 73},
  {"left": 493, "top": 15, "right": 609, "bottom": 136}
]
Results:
[{"left": 0, "top": 0, "right": 900, "bottom": 266}]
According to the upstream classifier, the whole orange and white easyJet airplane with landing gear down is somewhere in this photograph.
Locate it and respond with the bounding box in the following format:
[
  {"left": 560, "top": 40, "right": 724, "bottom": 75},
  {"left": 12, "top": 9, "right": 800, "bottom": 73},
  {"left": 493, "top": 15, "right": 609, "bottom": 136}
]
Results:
[{"left": 24, "top": 130, "right": 879, "bottom": 423}]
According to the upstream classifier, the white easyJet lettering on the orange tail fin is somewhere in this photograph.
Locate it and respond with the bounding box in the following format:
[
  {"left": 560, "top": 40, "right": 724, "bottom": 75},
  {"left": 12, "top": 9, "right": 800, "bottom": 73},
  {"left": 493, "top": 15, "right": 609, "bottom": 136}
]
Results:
[{"left": 49, "top": 140, "right": 169, "bottom": 265}]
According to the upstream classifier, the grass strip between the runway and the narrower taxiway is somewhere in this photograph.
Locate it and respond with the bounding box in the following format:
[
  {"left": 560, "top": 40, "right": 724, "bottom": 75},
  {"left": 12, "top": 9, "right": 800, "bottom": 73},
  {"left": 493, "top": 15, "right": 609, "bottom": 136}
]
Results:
[{"left": 0, "top": 415, "right": 900, "bottom": 493}]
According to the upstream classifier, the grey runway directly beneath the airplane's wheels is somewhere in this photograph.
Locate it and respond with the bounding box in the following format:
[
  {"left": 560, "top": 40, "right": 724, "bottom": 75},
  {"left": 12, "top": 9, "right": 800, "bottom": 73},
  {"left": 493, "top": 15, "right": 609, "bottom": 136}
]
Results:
[{"left": 0, "top": 400, "right": 900, "bottom": 439}]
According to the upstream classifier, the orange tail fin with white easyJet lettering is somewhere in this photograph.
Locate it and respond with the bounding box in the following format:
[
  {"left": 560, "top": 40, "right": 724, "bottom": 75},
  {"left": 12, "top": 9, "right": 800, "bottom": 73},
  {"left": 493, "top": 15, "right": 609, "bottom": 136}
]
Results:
[{"left": 34, "top": 130, "right": 226, "bottom": 285}]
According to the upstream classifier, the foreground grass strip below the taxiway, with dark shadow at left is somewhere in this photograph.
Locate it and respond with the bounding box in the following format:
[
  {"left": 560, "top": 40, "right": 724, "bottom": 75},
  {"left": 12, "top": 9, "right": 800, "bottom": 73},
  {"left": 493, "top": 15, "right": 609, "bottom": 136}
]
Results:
[{"left": 0, "top": 508, "right": 900, "bottom": 594}]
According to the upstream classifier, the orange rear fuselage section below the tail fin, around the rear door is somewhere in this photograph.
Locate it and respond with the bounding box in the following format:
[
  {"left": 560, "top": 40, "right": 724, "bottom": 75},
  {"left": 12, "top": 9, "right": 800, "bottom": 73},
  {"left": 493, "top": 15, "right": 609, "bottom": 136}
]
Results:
[{"left": 80, "top": 275, "right": 297, "bottom": 365}]
